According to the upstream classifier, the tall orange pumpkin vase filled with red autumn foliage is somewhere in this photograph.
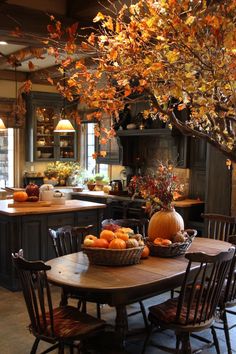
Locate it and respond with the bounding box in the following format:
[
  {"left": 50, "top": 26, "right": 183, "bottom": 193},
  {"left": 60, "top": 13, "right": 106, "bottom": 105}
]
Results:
[{"left": 128, "top": 163, "right": 184, "bottom": 241}]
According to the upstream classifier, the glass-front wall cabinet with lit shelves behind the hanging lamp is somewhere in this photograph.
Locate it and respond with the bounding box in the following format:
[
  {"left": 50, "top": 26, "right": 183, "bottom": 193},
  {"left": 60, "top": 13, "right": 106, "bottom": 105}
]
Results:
[{"left": 26, "top": 92, "right": 77, "bottom": 161}]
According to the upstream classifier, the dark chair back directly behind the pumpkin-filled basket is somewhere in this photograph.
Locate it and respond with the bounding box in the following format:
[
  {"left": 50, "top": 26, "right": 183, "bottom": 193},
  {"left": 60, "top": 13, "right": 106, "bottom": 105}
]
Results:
[{"left": 102, "top": 218, "right": 149, "bottom": 238}]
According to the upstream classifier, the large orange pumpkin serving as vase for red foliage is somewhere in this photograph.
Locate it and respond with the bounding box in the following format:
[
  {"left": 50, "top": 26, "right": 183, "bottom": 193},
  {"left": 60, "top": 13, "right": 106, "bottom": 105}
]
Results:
[{"left": 148, "top": 209, "right": 184, "bottom": 241}]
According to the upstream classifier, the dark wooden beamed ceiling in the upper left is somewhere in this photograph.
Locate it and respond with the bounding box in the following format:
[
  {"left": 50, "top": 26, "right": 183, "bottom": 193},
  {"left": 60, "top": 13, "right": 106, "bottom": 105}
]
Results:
[{"left": 0, "top": 0, "right": 108, "bottom": 84}]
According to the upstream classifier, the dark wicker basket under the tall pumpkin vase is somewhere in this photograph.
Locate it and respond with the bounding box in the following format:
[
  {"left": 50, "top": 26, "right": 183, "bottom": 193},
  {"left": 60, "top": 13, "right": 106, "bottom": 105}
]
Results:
[{"left": 147, "top": 229, "right": 197, "bottom": 258}]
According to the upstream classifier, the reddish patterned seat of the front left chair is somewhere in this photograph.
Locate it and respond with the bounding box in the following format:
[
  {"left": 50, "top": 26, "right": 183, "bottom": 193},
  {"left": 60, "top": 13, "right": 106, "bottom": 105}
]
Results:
[{"left": 32, "top": 306, "right": 105, "bottom": 339}]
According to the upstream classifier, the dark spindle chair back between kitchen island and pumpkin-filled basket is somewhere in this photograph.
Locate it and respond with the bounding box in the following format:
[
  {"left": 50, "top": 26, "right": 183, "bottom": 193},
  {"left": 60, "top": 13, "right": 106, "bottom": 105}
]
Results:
[{"left": 48, "top": 225, "right": 93, "bottom": 257}]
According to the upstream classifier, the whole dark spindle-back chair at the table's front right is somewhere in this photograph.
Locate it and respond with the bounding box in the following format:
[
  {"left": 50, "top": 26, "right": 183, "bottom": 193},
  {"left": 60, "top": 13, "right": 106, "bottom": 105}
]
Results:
[{"left": 143, "top": 247, "right": 235, "bottom": 353}]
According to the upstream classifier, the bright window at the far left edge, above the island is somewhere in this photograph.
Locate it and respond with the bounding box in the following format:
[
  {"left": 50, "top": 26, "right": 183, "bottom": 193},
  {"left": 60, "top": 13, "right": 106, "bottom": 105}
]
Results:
[{"left": 0, "top": 128, "right": 14, "bottom": 187}]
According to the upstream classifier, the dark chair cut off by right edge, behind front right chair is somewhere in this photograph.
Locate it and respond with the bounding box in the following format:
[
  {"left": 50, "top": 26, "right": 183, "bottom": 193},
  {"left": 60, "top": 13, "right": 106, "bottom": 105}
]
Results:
[{"left": 214, "top": 235, "right": 236, "bottom": 354}]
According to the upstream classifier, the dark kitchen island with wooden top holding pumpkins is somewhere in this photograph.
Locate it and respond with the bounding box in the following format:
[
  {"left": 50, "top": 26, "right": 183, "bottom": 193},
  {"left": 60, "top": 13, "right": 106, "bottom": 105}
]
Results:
[{"left": 0, "top": 200, "right": 106, "bottom": 290}]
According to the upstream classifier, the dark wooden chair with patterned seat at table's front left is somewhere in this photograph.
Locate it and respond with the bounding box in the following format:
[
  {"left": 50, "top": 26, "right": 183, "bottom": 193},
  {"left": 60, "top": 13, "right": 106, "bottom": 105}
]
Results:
[{"left": 12, "top": 251, "right": 105, "bottom": 354}]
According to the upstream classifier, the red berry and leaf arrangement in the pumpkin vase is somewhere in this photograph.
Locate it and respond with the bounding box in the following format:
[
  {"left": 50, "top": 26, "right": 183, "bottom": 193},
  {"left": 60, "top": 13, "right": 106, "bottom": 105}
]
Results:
[{"left": 128, "top": 163, "right": 184, "bottom": 215}]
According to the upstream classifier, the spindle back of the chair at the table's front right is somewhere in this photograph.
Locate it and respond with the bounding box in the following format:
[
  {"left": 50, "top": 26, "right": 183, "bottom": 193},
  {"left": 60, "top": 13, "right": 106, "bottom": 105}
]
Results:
[{"left": 176, "top": 247, "right": 235, "bottom": 326}]
